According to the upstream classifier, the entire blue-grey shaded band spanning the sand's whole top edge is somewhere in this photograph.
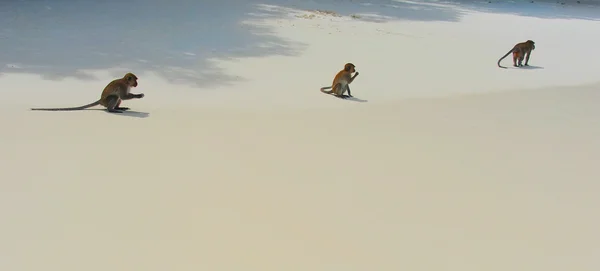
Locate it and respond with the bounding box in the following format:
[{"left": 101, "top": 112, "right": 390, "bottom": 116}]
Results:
[{"left": 0, "top": 0, "right": 600, "bottom": 91}]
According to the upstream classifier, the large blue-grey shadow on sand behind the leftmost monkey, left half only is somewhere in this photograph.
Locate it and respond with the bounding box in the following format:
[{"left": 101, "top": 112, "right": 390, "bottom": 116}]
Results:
[{"left": 0, "top": 0, "right": 306, "bottom": 87}]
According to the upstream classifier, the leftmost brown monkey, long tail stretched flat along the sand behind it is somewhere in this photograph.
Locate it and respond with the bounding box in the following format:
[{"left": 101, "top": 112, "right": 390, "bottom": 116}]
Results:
[{"left": 31, "top": 72, "right": 144, "bottom": 113}]
